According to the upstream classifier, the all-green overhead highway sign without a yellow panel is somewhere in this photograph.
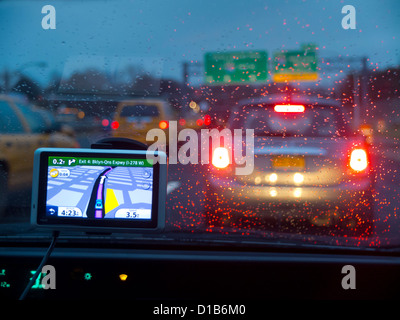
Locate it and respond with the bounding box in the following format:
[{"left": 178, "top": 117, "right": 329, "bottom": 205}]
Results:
[{"left": 204, "top": 51, "right": 268, "bottom": 84}]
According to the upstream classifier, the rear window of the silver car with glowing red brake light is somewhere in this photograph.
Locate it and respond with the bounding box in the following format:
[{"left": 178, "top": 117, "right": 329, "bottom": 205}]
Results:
[{"left": 230, "top": 104, "right": 350, "bottom": 137}]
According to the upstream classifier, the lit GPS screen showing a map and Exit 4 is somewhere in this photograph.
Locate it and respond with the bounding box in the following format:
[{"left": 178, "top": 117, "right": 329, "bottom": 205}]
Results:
[{"left": 46, "top": 157, "right": 153, "bottom": 220}]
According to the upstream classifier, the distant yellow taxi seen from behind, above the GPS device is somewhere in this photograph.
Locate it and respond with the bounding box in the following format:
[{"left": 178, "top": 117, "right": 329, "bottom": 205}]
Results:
[{"left": 111, "top": 98, "right": 176, "bottom": 145}]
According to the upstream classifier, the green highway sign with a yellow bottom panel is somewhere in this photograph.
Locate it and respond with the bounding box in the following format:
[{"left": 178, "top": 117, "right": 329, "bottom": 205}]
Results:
[{"left": 272, "top": 50, "right": 318, "bottom": 82}]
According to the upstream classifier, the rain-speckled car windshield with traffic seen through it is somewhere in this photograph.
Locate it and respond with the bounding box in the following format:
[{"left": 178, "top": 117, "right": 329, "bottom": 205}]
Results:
[{"left": 0, "top": 0, "right": 400, "bottom": 249}]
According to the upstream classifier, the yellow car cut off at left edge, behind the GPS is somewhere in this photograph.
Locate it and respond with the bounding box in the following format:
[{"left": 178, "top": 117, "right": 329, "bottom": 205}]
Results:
[{"left": 0, "top": 95, "right": 79, "bottom": 217}]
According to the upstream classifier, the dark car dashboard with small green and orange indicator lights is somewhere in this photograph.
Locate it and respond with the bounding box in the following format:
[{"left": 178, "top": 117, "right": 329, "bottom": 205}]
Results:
[{"left": 0, "top": 237, "right": 400, "bottom": 302}]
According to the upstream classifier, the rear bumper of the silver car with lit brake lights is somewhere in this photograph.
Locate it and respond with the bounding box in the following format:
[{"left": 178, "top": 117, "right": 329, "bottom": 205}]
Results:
[{"left": 208, "top": 178, "right": 372, "bottom": 214}]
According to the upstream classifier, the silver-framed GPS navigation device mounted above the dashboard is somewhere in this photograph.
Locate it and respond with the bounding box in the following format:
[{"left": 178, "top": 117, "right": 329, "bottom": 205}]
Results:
[{"left": 31, "top": 148, "right": 167, "bottom": 232}]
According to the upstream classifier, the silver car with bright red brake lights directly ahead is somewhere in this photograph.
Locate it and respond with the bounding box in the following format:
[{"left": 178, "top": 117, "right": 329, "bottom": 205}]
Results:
[{"left": 206, "top": 95, "right": 374, "bottom": 234}]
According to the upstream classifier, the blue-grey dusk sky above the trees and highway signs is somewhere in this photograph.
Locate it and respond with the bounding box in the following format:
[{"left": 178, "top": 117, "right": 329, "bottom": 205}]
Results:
[{"left": 0, "top": 0, "right": 400, "bottom": 87}]
